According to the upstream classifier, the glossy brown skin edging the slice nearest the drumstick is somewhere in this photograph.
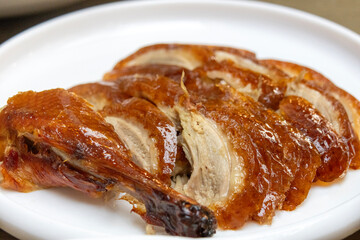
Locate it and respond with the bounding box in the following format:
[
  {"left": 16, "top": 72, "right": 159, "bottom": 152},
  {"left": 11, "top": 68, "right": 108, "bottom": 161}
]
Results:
[{"left": 69, "top": 82, "right": 178, "bottom": 184}]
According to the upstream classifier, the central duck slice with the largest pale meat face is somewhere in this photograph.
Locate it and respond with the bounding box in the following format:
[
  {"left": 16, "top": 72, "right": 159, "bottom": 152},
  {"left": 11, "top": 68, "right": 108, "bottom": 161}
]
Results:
[{"left": 101, "top": 74, "right": 269, "bottom": 229}]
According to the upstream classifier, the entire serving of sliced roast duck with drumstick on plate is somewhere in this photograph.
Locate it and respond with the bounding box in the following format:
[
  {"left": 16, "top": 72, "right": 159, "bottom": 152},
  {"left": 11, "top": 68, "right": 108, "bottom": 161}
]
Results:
[{"left": 0, "top": 44, "right": 360, "bottom": 237}]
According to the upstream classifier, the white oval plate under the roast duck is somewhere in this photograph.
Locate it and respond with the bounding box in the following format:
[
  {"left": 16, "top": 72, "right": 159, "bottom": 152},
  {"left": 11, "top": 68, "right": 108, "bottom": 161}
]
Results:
[{"left": 0, "top": 1, "right": 360, "bottom": 239}]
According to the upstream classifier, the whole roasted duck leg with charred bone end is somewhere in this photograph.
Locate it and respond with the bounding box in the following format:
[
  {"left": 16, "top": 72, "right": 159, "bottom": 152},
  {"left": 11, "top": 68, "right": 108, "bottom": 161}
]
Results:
[{"left": 0, "top": 89, "right": 216, "bottom": 237}]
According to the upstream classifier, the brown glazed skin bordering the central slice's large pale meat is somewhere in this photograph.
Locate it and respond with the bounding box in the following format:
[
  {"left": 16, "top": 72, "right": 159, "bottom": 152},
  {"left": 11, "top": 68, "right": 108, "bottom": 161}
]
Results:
[{"left": 105, "top": 70, "right": 271, "bottom": 229}]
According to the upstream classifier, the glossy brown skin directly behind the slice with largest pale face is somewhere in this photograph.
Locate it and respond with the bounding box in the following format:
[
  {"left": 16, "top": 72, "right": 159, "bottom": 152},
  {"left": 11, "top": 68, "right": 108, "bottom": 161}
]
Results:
[{"left": 106, "top": 64, "right": 320, "bottom": 218}]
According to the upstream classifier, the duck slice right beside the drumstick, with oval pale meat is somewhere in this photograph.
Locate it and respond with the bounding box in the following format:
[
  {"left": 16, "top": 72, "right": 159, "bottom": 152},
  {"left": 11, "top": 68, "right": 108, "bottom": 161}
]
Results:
[{"left": 69, "top": 82, "right": 180, "bottom": 184}]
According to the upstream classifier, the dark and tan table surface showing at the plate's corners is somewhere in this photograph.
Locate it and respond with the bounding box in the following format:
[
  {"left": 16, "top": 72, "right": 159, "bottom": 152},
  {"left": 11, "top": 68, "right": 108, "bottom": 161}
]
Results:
[{"left": 0, "top": 0, "right": 360, "bottom": 240}]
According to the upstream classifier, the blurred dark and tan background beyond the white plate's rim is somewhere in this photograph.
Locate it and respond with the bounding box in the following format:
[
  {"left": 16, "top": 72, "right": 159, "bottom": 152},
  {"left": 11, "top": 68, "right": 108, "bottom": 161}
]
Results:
[{"left": 0, "top": 0, "right": 360, "bottom": 240}]
